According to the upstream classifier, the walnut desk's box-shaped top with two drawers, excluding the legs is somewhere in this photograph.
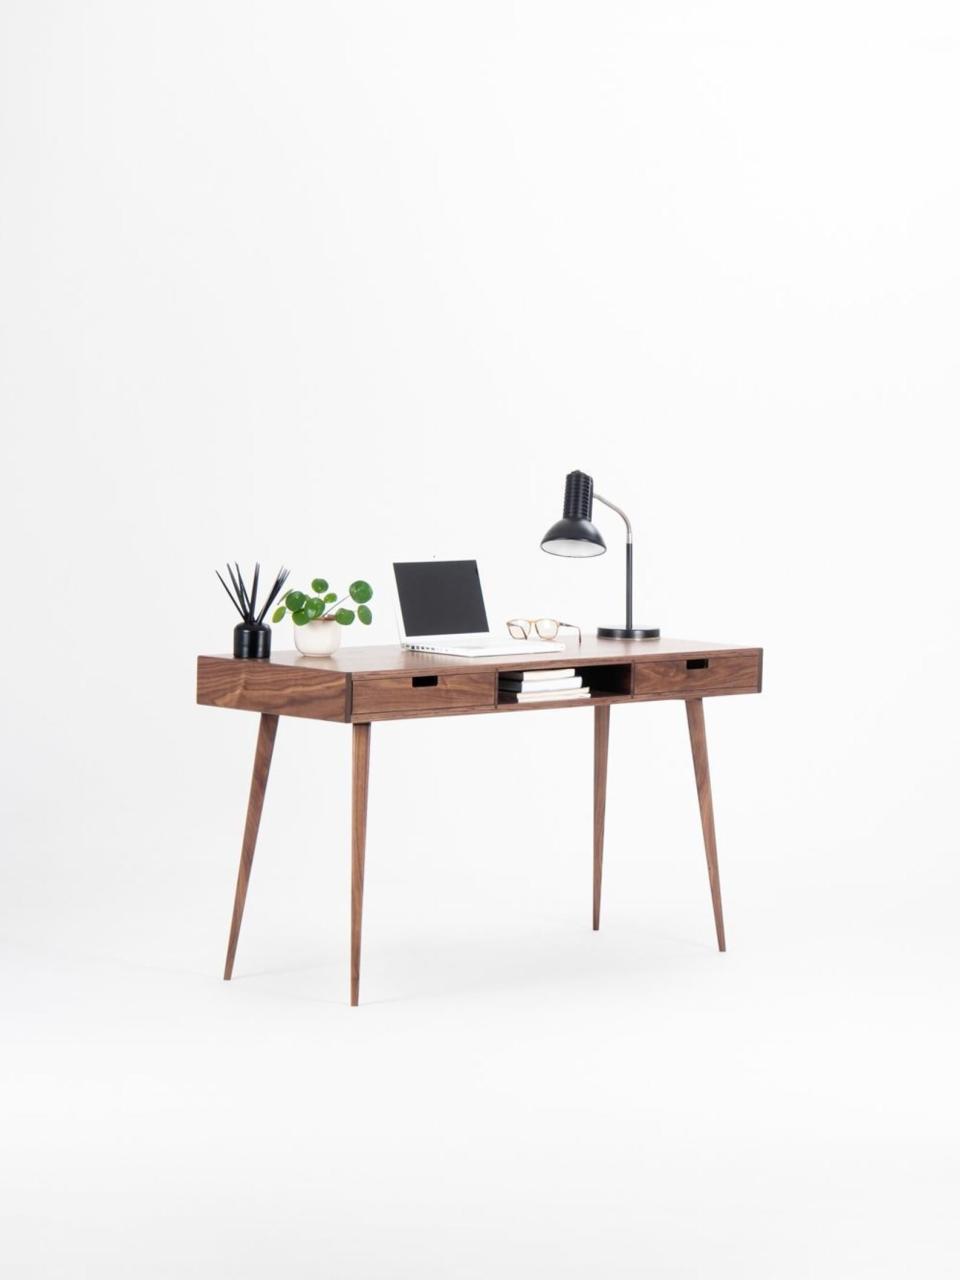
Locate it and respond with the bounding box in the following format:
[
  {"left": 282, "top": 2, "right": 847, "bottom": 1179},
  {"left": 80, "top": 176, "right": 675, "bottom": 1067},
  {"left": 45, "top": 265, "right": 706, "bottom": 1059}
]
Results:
[{"left": 197, "top": 636, "right": 763, "bottom": 723}]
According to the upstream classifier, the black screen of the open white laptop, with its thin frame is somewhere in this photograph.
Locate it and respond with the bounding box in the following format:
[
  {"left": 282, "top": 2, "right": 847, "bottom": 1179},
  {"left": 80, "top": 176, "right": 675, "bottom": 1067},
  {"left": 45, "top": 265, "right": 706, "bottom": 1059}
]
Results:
[{"left": 393, "top": 561, "right": 489, "bottom": 636}]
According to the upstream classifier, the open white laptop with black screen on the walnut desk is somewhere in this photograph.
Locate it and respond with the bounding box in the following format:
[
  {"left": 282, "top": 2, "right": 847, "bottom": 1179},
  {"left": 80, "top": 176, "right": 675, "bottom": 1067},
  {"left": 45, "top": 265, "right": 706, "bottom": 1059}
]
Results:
[{"left": 393, "top": 561, "right": 563, "bottom": 658}]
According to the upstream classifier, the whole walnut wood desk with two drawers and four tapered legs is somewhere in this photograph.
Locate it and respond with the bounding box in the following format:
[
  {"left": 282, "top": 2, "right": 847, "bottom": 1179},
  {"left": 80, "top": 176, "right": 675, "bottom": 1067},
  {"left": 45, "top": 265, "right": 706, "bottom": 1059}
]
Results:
[{"left": 197, "top": 637, "right": 763, "bottom": 1005}]
